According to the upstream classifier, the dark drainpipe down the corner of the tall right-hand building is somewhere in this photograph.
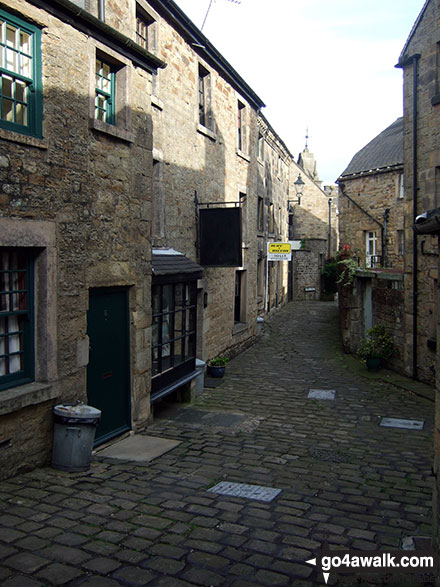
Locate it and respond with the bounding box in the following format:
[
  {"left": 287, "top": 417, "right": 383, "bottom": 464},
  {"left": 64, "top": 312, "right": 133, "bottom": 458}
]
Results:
[{"left": 396, "top": 53, "right": 421, "bottom": 379}]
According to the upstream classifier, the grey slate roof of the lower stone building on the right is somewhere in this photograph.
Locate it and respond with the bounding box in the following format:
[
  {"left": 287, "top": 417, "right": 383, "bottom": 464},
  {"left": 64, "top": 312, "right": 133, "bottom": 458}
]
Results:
[{"left": 340, "top": 118, "right": 403, "bottom": 177}]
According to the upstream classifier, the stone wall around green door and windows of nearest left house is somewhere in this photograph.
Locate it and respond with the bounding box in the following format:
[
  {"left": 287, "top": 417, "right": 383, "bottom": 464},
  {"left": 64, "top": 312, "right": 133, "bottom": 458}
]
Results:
[{"left": 0, "top": 0, "right": 156, "bottom": 476}]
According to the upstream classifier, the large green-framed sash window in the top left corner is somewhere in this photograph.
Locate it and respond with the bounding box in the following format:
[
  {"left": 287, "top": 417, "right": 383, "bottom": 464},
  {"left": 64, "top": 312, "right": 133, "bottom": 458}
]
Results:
[{"left": 0, "top": 10, "right": 43, "bottom": 137}]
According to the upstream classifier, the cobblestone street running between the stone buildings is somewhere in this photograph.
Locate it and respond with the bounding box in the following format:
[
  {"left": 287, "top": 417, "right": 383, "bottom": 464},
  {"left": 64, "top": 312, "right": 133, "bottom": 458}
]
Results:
[{"left": 0, "top": 302, "right": 434, "bottom": 587}]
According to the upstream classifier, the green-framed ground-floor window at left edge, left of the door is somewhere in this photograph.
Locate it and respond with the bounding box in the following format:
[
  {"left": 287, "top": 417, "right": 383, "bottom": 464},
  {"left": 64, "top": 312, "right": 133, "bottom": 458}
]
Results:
[{"left": 0, "top": 248, "right": 33, "bottom": 389}]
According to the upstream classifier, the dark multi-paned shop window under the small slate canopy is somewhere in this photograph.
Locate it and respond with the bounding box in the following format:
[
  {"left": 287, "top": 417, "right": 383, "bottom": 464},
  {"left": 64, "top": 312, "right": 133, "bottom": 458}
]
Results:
[{"left": 152, "top": 281, "right": 197, "bottom": 378}]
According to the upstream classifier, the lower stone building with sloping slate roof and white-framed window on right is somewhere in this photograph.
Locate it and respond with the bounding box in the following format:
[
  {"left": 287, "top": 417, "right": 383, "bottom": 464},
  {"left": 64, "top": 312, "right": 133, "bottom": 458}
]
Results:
[{"left": 338, "top": 118, "right": 407, "bottom": 372}]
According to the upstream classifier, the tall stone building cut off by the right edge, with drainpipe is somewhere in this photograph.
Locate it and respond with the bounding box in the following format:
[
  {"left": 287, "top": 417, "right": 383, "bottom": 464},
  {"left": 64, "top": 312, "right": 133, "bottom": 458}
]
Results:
[{"left": 397, "top": 0, "right": 440, "bottom": 560}]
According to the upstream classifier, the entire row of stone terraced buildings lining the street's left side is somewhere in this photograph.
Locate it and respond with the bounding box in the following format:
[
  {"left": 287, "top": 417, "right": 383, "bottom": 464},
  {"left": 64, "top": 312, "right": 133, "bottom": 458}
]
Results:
[{"left": 0, "top": 0, "right": 336, "bottom": 475}]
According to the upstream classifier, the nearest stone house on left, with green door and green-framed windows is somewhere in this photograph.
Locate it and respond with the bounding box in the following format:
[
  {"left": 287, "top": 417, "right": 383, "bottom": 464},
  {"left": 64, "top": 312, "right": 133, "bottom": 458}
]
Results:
[{"left": 0, "top": 0, "right": 164, "bottom": 475}]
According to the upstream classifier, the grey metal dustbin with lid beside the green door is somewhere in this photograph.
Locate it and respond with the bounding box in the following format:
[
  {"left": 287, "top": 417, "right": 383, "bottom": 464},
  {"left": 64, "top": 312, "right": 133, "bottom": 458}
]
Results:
[{"left": 52, "top": 404, "right": 101, "bottom": 472}]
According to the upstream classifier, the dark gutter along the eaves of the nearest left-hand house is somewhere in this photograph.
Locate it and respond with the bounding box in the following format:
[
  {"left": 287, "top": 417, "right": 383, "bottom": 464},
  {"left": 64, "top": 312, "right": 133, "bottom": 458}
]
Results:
[{"left": 28, "top": 0, "right": 167, "bottom": 73}]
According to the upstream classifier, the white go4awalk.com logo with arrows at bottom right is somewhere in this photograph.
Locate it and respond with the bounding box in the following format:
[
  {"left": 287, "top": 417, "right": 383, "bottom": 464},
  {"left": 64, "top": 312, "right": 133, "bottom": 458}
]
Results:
[{"left": 306, "top": 548, "right": 438, "bottom": 585}]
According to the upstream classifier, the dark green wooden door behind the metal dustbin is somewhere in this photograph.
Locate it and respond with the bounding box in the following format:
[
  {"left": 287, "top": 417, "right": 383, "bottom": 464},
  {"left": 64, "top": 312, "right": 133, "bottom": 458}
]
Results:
[{"left": 87, "top": 288, "right": 131, "bottom": 444}]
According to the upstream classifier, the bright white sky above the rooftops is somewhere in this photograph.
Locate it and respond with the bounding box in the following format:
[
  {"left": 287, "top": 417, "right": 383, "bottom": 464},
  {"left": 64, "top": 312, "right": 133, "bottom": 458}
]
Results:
[{"left": 171, "top": 0, "right": 425, "bottom": 183}]
